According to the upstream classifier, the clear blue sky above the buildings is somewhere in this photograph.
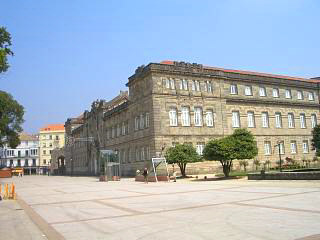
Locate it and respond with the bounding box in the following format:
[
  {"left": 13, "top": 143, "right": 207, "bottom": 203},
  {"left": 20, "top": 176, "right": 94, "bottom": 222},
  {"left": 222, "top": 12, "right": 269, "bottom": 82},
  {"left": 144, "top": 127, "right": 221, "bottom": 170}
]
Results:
[{"left": 0, "top": 0, "right": 320, "bottom": 133}]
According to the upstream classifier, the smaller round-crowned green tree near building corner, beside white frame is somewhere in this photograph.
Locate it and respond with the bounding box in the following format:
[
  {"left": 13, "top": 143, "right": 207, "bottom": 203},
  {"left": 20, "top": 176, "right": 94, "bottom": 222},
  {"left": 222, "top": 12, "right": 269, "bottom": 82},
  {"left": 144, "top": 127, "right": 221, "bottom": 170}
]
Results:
[{"left": 165, "top": 144, "right": 201, "bottom": 177}]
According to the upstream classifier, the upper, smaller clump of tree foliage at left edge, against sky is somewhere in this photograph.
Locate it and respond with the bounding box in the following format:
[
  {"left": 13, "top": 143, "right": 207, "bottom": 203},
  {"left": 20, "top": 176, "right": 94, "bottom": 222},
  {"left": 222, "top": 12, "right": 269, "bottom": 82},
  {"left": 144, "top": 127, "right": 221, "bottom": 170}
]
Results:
[{"left": 0, "top": 27, "right": 13, "bottom": 73}]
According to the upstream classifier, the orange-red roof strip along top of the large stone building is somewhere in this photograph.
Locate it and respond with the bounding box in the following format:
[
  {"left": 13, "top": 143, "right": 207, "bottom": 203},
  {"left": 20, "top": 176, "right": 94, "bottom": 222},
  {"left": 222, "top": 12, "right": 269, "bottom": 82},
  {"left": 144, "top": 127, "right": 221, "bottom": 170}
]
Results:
[{"left": 160, "top": 60, "right": 320, "bottom": 83}]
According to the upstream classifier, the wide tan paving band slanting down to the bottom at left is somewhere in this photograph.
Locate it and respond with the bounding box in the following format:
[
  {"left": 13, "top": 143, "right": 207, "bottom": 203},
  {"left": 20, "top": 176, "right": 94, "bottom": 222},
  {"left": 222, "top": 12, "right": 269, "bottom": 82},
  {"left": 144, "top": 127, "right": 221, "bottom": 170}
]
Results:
[{"left": 17, "top": 195, "right": 65, "bottom": 240}]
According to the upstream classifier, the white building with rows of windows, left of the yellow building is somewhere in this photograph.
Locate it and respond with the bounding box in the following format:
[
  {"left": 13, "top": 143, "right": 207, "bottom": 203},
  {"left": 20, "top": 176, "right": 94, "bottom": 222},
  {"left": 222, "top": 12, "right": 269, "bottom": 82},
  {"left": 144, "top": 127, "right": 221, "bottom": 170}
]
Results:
[{"left": 0, "top": 133, "right": 39, "bottom": 174}]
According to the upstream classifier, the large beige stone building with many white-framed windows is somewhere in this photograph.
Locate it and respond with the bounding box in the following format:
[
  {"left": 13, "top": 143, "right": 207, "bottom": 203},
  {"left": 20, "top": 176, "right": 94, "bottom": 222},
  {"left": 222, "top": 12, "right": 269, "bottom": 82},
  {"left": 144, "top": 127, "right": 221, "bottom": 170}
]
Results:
[{"left": 63, "top": 61, "right": 319, "bottom": 175}]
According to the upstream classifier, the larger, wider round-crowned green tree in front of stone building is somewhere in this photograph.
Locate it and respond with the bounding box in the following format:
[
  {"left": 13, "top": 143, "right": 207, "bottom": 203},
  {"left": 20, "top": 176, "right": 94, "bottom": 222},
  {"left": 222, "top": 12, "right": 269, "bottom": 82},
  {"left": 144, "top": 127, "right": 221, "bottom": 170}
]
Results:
[{"left": 203, "top": 129, "right": 258, "bottom": 177}]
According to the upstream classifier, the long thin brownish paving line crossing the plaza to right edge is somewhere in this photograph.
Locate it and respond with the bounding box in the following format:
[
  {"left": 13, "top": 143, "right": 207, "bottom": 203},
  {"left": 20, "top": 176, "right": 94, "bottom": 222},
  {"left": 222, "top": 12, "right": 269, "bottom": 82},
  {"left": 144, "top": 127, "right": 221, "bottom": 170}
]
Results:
[{"left": 51, "top": 188, "right": 319, "bottom": 224}]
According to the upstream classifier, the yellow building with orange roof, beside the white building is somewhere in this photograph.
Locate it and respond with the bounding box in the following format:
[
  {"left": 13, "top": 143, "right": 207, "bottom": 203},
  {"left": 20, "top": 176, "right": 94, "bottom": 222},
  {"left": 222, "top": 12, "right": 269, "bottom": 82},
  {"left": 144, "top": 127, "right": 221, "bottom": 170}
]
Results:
[{"left": 39, "top": 124, "right": 65, "bottom": 173}]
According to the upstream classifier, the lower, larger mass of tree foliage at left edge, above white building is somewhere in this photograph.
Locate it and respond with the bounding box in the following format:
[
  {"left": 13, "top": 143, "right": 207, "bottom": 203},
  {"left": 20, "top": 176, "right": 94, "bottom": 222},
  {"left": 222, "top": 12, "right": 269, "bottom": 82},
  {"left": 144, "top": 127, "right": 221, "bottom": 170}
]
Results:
[{"left": 0, "top": 91, "right": 24, "bottom": 148}]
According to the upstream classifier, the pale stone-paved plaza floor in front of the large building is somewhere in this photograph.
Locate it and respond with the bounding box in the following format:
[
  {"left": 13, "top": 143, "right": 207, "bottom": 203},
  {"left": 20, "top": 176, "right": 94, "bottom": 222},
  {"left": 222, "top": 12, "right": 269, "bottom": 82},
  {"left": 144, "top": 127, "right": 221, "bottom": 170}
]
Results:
[{"left": 0, "top": 176, "right": 320, "bottom": 240}]
